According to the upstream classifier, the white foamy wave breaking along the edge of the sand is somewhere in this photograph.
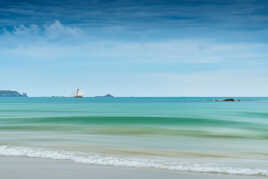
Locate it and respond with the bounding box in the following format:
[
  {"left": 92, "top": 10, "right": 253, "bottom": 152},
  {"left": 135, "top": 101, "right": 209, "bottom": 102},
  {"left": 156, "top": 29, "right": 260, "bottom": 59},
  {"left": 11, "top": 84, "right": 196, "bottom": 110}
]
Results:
[{"left": 0, "top": 145, "right": 268, "bottom": 176}]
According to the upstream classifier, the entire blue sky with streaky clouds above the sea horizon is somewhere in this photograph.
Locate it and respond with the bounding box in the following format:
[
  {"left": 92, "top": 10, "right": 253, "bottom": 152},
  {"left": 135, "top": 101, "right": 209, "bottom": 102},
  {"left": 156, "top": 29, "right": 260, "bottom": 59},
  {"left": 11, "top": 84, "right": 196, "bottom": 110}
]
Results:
[{"left": 0, "top": 0, "right": 268, "bottom": 96}]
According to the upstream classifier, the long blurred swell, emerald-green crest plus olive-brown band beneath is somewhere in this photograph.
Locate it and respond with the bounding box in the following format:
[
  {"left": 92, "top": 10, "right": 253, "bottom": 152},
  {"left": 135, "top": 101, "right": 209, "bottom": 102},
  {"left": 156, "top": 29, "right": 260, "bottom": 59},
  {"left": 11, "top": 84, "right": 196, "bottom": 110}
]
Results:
[{"left": 0, "top": 116, "right": 268, "bottom": 139}]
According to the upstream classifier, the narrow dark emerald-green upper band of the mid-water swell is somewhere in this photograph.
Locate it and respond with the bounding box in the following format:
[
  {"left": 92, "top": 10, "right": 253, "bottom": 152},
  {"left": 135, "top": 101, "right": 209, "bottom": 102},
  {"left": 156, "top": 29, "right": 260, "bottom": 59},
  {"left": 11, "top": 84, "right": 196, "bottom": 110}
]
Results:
[{"left": 2, "top": 116, "right": 252, "bottom": 127}]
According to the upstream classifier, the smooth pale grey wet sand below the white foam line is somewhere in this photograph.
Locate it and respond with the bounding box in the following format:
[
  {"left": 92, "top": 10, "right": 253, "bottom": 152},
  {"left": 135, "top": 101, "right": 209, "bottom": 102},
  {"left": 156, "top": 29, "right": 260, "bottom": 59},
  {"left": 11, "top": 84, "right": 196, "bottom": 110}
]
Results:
[{"left": 0, "top": 157, "right": 266, "bottom": 179}]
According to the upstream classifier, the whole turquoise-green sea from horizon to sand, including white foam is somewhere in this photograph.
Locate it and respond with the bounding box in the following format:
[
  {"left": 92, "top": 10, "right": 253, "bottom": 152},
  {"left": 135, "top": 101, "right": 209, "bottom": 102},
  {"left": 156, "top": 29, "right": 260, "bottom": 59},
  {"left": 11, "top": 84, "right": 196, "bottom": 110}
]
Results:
[{"left": 0, "top": 97, "right": 268, "bottom": 176}]
